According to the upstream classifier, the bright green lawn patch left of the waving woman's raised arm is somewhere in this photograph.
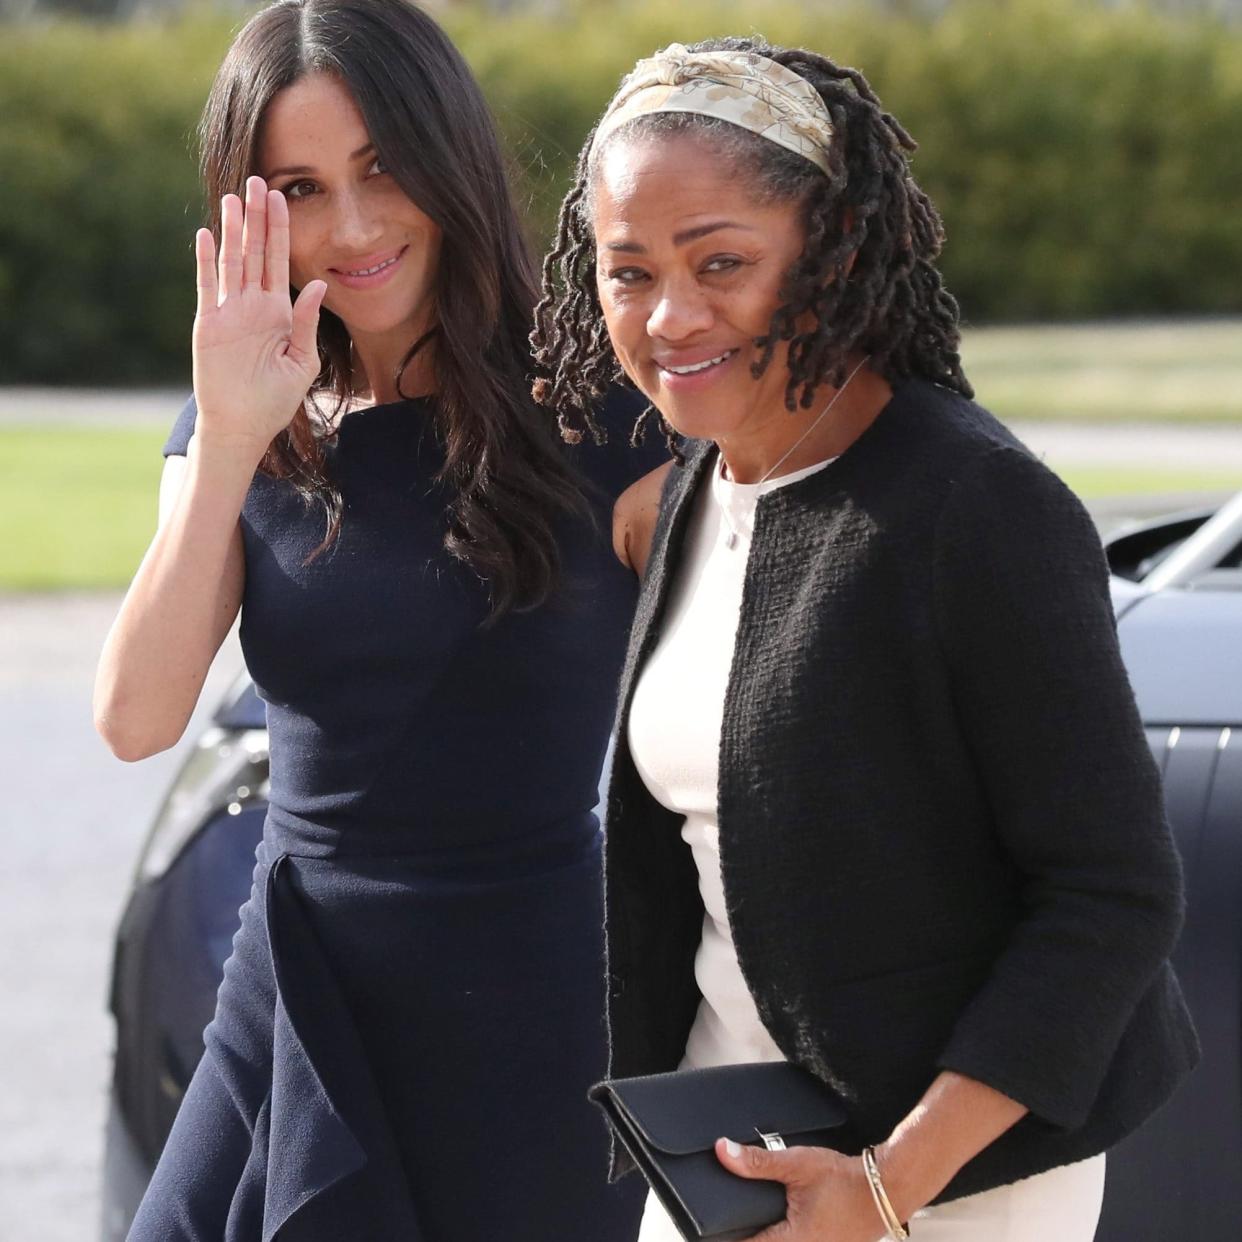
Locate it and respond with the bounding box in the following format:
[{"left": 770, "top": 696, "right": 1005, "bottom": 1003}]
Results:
[{"left": 0, "top": 426, "right": 166, "bottom": 591}]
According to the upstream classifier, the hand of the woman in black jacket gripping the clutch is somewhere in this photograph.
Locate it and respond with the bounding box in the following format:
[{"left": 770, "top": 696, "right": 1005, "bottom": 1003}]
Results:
[{"left": 715, "top": 1139, "right": 899, "bottom": 1242}]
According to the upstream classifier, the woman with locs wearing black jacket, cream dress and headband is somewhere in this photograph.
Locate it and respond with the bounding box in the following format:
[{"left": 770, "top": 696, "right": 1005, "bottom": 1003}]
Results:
[{"left": 534, "top": 40, "right": 1197, "bottom": 1242}]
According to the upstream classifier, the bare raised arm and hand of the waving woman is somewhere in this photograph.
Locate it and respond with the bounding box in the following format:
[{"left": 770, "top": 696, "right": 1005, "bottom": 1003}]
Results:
[{"left": 94, "top": 178, "right": 324, "bottom": 760}]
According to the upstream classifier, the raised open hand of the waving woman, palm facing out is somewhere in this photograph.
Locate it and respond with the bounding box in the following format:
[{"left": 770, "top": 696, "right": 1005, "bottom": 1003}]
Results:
[{"left": 194, "top": 176, "right": 328, "bottom": 461}]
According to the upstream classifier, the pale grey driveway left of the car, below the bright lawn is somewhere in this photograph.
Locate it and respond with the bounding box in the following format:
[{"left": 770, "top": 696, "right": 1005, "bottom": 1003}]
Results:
[{"left": 0, "top": 595, "right": 241, "bottom": 1242}]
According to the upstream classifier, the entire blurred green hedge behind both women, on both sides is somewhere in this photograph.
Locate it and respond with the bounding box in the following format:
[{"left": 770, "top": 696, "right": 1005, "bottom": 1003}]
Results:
[{"left": 0, "top": 0, "right": 1242, "bottom": 384}]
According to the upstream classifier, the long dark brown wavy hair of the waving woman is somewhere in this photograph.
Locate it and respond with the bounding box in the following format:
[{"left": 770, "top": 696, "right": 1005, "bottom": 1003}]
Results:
[{"left": 200, "top": 0, "right": 584, "bottom": 617}]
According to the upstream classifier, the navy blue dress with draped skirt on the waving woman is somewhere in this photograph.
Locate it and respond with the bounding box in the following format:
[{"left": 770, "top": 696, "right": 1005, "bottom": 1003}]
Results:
[{"left": 130, "top": 401, "right": 663, "bottom": 1242}]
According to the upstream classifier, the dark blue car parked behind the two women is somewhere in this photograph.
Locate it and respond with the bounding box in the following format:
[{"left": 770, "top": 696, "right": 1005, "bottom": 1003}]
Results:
[{"left": 103, "top": 494, "right": 1242, "bottom": 1242}]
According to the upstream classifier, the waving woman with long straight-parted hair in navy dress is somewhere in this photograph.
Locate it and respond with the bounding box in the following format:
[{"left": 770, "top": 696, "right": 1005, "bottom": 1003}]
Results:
[{"left": 96, "top": 0, "right": 667, "bottom": 1242}]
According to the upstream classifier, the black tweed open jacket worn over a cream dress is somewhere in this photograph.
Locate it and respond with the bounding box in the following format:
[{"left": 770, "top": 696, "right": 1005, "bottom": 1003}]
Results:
[{"left": 606, "top": 380, "right": 1197, "bottom": 1200}]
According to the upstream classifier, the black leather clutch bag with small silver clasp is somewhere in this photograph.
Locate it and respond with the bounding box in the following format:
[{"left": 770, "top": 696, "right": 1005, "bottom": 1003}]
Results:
[{"left": 590, "top": 1061, "right": 846, "bottom": 1242}]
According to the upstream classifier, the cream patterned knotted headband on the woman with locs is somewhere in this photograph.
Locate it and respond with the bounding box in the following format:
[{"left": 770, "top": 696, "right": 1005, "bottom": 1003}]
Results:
[{"left": 591, "top": 43, "right": 832, "bottom": 173}]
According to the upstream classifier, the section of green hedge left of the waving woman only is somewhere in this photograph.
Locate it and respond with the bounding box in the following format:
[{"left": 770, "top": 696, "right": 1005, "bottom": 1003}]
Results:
[{"left": 0, "top": 15, "right": 229, "bottom": 384}]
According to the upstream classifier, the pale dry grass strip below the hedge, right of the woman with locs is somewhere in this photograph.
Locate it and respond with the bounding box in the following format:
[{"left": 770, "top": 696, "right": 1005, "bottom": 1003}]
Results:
[{"left": 961, "top": 319, "right": 1242, "bottom": 424}]
